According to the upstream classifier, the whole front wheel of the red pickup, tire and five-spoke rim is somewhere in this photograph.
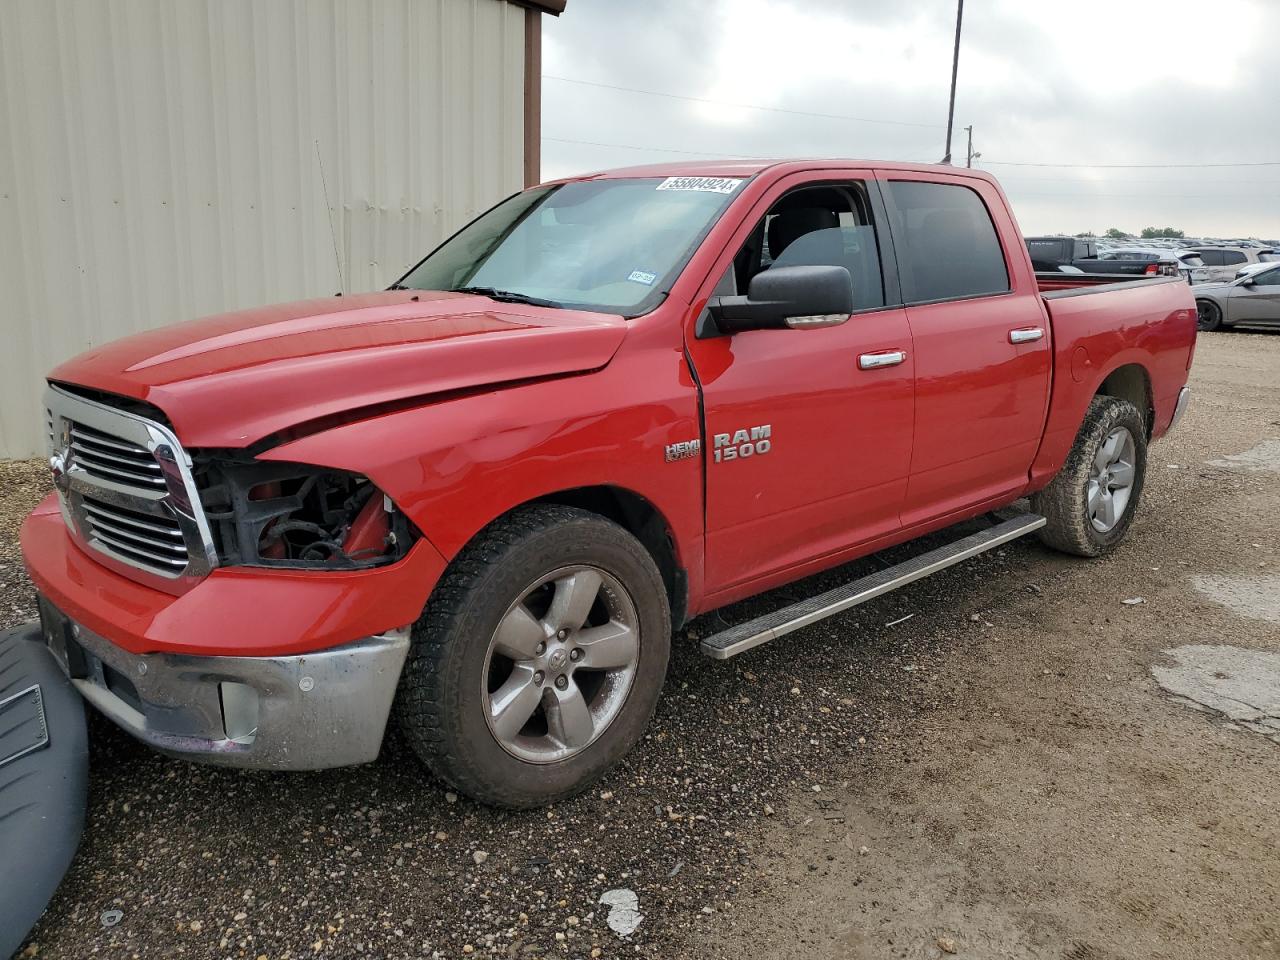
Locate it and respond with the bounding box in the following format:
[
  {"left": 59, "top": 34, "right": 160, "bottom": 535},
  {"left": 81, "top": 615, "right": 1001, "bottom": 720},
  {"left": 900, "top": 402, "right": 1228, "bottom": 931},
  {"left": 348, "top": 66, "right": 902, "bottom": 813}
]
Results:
[{"left": 396, "top": 504, "right": 671, "bottom": 808}]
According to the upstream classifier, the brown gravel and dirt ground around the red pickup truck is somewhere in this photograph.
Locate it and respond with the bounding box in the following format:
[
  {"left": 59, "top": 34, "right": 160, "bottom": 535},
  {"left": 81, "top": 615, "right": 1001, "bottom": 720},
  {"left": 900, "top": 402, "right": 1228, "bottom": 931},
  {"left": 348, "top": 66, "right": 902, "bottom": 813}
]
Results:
[{"left": 10, "top": 333, "right": 1280, "bottom": 960}]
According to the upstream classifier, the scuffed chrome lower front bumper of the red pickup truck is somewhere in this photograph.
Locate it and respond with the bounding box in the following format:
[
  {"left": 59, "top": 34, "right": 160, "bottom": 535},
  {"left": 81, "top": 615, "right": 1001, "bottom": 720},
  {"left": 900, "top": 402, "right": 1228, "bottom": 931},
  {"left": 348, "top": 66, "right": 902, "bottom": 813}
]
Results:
[{"left": 40, "top": 598, "right": 410, "bottom": 771}]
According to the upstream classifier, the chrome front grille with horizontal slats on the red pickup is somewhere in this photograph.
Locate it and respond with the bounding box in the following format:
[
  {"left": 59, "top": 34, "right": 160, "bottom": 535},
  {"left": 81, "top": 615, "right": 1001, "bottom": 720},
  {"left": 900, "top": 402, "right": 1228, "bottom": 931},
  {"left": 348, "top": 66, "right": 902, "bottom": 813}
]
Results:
[{"left": 45, "top": 385, "right": 218, "bottom": 593}]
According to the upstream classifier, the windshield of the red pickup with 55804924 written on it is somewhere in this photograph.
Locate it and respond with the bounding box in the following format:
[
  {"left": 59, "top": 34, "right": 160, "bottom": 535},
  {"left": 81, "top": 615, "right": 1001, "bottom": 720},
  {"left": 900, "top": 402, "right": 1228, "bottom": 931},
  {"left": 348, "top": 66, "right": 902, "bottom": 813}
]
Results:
[{"left": 397, "top": 177, "right": 742, "bottom": 316}]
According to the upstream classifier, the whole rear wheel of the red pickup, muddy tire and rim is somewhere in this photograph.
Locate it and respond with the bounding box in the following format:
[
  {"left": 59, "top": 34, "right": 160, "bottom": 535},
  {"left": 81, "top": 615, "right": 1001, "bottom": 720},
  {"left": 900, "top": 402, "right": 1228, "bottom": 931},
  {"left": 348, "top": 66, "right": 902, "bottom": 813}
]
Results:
[{"left": 1032, "top": 397, "right": 1147, "bottom": 557}]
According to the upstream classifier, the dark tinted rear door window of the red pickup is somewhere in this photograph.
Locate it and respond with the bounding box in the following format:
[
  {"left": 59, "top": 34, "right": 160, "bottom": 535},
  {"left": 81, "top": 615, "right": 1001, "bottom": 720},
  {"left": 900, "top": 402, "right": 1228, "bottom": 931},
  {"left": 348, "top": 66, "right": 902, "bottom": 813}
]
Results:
[{"left": 884, "top": 180, "right": 1009, "bottom": 303}]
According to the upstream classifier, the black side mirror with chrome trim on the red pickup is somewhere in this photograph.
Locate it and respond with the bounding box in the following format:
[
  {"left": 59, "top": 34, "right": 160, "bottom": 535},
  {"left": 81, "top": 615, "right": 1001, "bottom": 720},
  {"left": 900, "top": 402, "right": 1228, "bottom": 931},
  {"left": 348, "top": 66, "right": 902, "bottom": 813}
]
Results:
[{"left": 707, "top": 265, "right": 854, "bottom": 333}]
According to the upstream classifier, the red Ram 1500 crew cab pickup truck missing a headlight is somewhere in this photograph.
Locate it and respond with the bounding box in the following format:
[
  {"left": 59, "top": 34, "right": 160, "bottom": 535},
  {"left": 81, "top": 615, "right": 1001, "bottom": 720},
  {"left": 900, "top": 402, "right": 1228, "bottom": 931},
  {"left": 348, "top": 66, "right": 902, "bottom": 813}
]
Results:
[{"left": 22, "top": 160, "right": 1196, "bottom": 806}]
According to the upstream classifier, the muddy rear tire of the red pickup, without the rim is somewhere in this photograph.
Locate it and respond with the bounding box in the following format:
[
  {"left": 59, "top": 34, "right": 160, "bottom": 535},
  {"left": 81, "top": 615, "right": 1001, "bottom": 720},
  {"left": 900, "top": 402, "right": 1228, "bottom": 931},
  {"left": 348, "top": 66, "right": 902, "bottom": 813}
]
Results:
[{"left": 1032, "top": 397, "right": 1147, "bottom": 557}]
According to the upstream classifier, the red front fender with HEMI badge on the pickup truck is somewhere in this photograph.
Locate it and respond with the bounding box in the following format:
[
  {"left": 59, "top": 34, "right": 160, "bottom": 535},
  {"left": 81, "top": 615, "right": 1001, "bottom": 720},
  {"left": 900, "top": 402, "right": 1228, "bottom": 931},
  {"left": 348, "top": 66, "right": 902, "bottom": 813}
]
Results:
[{"left": 259, "top": 325, "right": 703, "bottom": 609}]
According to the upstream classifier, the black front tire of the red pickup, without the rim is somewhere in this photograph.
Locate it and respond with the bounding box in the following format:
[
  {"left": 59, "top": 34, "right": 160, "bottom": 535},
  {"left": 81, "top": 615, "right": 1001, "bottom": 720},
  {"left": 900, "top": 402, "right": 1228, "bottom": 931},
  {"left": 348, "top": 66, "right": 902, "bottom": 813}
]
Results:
[{"left": 396, "top": 504, "right": 671, "bottom": 809}]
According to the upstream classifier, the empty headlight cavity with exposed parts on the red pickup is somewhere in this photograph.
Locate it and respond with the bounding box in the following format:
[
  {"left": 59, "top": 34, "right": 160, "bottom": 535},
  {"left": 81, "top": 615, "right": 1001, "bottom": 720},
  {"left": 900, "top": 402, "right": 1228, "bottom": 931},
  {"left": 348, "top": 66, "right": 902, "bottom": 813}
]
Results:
[{"left": 193, "top": 454, "right": 419, "bottom": 570}]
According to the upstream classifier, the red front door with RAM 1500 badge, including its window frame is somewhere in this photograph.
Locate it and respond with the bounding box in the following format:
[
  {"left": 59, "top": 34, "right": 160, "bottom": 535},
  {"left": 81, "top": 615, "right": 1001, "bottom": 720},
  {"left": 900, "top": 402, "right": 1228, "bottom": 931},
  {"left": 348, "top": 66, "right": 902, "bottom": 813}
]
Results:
[{"left": 686, "top": 172, "right": 914, "bottom": 596}]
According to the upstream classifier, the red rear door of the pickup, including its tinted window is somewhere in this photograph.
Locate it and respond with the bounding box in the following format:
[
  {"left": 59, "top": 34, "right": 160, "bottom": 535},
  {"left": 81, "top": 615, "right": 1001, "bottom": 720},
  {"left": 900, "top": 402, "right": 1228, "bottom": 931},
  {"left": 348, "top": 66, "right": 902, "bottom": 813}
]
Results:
[{"left": 883, "top": 174, "right": 1051, "bottom": 526}]
